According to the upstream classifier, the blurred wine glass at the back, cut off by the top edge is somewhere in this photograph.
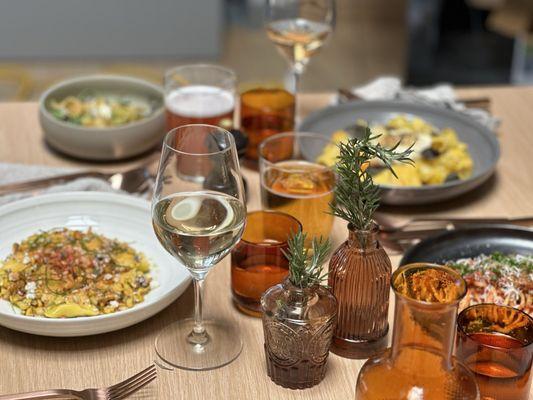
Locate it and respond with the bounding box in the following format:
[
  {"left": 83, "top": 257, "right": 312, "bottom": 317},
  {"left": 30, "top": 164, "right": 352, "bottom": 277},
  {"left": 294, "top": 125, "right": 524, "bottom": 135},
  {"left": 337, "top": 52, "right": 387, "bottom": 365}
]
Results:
[{"left": 266, "top": 0, "right": 335, "bottom": 94}]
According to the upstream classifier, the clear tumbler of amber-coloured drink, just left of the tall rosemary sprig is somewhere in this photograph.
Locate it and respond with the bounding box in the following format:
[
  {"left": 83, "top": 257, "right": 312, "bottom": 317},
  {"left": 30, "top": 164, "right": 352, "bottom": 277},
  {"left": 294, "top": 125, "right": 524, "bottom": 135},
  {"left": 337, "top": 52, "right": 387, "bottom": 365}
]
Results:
[{"left": 259, "top": 132, "right": 336, "bottom": 243}]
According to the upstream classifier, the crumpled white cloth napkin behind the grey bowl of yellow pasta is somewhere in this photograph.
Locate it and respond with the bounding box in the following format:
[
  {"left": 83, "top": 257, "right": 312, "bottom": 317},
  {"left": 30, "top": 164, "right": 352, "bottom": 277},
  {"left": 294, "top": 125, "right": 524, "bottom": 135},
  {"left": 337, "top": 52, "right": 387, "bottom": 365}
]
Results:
[{"left": 335, "top": 77, "right": 500, "bottom": 132}]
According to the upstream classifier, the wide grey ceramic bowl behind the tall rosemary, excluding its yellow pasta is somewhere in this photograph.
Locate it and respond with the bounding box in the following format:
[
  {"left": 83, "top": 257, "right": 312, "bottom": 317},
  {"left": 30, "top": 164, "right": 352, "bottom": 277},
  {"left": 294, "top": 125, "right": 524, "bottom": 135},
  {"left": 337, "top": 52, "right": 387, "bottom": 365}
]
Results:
[{"left": 299, "top": 101, "right": 500, "bottom": 205}]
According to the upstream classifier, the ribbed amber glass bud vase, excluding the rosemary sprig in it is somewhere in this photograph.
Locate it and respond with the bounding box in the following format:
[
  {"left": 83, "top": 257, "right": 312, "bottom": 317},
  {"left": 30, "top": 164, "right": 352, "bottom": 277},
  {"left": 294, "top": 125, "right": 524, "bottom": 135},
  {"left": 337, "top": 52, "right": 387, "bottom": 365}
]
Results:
[{"left": 328, "top": 224, "right": 391, "bottom": 358}]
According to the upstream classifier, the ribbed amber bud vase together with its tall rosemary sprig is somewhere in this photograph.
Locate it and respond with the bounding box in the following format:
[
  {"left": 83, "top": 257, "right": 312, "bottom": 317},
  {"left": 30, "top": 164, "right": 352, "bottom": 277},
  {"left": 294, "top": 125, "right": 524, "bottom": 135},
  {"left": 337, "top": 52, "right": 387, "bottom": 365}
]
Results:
[{"left": 328, "top": 128, "right": 412, "bottom": 359}]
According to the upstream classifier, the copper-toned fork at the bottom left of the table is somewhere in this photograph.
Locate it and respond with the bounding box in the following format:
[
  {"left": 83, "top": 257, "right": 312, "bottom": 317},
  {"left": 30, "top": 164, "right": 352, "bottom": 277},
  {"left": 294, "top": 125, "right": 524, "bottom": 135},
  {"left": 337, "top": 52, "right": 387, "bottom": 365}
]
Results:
[{"left": 0, "top": 364, "right": 157, "bottom": 400}]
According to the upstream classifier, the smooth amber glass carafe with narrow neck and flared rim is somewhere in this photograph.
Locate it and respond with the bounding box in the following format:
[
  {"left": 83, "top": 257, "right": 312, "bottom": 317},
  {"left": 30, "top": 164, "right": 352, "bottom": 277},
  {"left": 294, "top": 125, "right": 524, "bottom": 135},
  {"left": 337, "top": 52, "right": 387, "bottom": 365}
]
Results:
[{"left": 356, "top": 264, "right": 479, "bottom": 400}]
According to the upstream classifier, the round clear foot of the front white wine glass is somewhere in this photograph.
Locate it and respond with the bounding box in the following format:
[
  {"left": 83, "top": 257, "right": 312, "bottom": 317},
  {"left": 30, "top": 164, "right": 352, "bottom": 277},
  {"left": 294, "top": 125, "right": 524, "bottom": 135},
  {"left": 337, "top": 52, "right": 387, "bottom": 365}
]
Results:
[{"left": 155, "top": 318, "right": 242, "bottom": 371}]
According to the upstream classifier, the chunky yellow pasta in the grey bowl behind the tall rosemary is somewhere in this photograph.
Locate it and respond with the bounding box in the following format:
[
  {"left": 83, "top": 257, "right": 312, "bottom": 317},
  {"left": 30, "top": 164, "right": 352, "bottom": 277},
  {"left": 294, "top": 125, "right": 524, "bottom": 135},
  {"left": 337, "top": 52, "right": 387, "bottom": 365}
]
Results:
[{"left": 317, "top": 115, "right": 474, "bottom": 186}]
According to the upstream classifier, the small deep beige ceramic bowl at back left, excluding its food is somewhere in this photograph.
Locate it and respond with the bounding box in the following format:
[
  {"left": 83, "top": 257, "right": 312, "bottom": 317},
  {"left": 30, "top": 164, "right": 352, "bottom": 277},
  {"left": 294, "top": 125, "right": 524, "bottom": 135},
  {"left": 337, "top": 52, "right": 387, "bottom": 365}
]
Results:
[{"left": 39, "top": 75, "right": 165, "bottom": 160}]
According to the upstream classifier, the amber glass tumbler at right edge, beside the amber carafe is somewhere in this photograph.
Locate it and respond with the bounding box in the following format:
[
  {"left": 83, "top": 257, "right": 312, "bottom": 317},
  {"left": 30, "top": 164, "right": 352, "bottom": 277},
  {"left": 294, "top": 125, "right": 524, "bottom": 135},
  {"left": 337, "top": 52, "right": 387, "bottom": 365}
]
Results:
[{"left": 456, "top": 304, "right": 533, "bottom": 400}]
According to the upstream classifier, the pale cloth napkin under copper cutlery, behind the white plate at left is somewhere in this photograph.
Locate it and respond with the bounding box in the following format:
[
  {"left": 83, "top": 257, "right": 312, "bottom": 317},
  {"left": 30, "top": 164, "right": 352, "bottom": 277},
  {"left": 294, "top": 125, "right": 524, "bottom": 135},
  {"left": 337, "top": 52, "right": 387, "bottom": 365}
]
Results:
[{"left": 0, "top": 163, "right": 125, "bottom": 205}]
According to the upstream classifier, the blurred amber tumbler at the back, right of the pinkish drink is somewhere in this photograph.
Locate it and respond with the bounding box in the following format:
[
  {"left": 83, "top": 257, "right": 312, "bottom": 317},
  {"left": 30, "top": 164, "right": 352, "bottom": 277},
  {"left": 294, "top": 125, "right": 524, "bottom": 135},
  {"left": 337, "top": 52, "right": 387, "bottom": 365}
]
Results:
[{"left": 241, "top": 85, "right": 295, "bottom": 160}]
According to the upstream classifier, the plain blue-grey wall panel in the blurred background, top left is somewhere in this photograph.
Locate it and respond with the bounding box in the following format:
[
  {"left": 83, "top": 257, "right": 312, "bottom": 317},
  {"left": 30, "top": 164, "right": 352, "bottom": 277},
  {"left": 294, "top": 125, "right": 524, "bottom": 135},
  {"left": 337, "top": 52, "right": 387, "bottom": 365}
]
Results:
[{"left": 0, "top": 0, "right": 224, "bottom": 59}]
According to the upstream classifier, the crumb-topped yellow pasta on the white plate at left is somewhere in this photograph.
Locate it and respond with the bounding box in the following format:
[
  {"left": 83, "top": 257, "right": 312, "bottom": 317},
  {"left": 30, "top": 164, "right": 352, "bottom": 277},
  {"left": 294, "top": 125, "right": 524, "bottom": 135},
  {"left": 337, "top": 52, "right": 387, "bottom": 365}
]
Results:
[{"left": 0, "top": 229, "right": 152, "bottom": 318}]
